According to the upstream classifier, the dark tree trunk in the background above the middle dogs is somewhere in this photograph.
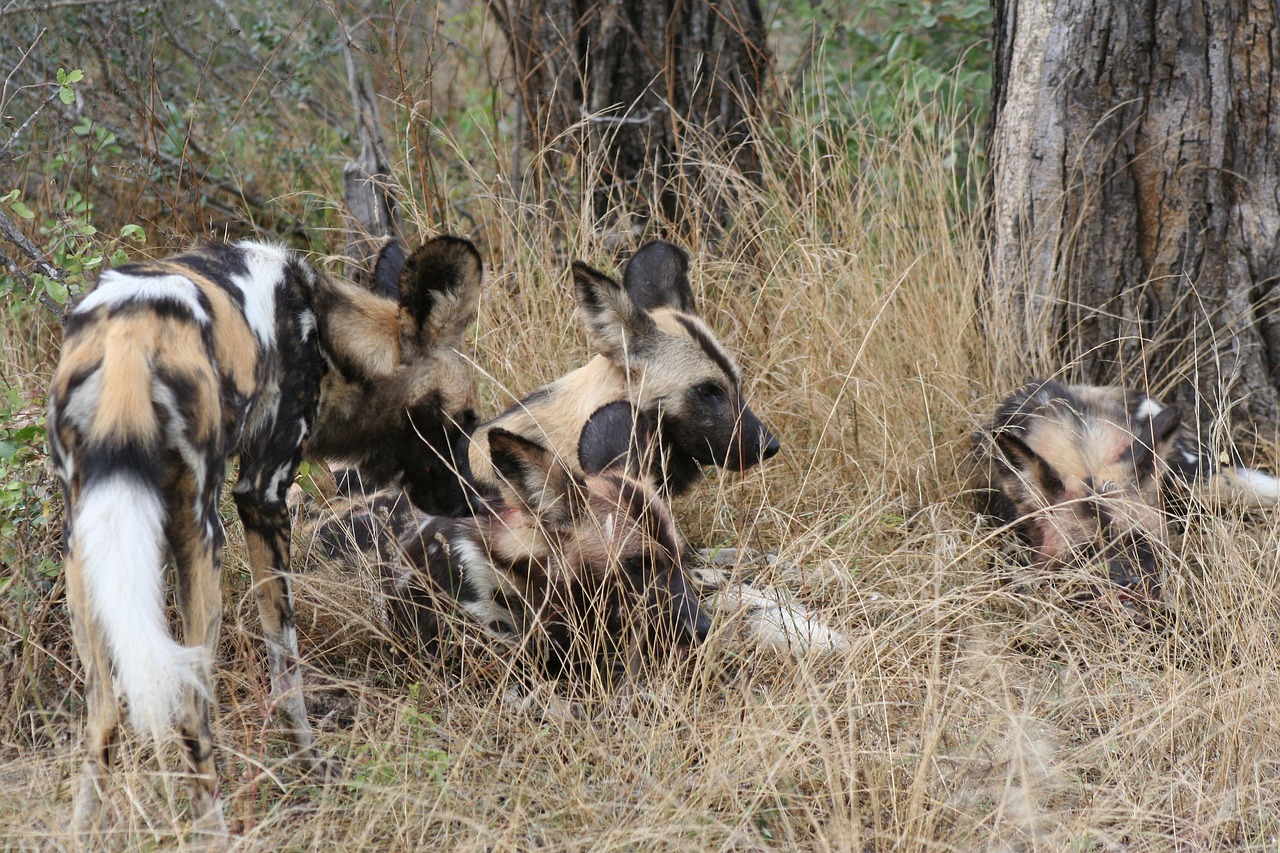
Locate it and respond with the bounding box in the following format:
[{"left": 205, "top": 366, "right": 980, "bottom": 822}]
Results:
[{"left": 489, "top": 0, "right": 769, "bottom": 233}]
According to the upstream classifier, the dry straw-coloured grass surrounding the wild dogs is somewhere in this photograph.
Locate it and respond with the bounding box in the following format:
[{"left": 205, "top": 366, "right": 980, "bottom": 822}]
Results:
[{"left": 0, "top": 1, "right": 1280, "bottom": 850}]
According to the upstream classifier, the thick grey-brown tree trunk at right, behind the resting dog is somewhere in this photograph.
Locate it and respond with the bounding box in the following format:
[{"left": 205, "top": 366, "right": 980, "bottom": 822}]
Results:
[{"left": 986, "top": 0, "right": 1280, "bottom": 434}]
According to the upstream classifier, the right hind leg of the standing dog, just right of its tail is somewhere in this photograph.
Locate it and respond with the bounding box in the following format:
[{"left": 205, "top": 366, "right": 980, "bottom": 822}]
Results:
[{"left": 166, "top": 485, "right": 227, "bottom": 834}]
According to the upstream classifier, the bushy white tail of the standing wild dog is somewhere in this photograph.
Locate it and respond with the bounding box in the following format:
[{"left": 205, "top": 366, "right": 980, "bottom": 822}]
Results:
[{"left": 72, "top": 475, "right": 207, "bottom": 736}]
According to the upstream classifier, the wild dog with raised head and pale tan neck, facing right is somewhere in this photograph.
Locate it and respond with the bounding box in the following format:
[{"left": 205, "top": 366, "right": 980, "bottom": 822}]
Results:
[{"left": 470, "top": 242, "right": 780, "bottom": 494}]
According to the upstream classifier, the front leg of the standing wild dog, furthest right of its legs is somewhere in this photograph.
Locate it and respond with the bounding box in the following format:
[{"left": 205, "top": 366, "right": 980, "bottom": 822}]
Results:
[{"left": 234, "top": 479, "right": 339, "bottom": 779}]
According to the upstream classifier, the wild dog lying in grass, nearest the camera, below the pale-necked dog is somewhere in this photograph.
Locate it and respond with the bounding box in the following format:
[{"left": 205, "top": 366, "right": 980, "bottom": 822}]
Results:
[{"left": 384, "top": 429, "right": 710, "bottom": 678}]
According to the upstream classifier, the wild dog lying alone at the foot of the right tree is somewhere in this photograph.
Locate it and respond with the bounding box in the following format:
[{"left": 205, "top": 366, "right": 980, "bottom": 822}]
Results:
[{"left": 975, "top": 380, "right": 1280, "bottom": 602}]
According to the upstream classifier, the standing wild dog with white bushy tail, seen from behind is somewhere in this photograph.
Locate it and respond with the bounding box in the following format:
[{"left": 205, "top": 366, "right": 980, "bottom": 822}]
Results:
[{"left": 49, "top": 237, "right": 481, "bottom": 831}]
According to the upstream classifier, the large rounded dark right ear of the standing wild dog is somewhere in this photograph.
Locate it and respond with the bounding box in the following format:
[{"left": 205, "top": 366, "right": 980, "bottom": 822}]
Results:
[{"left": 399, "top": 237, "right": 484, "bottom": 346}]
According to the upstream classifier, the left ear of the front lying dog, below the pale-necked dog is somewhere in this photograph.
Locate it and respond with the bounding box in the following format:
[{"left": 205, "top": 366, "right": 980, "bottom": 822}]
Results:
[{"left": 489, "top": 429, "right": 582, "bottom": 526}]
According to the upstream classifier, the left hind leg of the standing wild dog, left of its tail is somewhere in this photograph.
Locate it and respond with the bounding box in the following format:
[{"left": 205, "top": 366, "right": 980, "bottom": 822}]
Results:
[{"left": 67, "top": 548, "right": 120, "bottom": 835}]
